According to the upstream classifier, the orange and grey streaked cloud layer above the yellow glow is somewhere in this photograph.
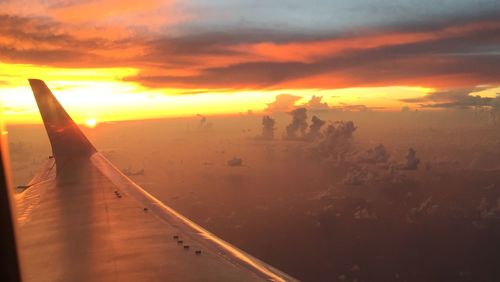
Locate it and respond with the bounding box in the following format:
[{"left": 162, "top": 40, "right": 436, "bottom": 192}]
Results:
[{"left": 0, "top": 0, "right": 500, "bottom": 92}]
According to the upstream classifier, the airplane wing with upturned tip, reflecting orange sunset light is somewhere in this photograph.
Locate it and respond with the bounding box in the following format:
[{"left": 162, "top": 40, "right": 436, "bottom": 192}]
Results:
[{"left": 0, "top": 79, "right": 297, "bottom": 281}]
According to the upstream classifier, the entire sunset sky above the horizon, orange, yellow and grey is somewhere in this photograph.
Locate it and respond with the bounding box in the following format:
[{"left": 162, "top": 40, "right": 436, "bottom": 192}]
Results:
[{"left": 0, "top": 0, "right": 500, "bottom": 123}]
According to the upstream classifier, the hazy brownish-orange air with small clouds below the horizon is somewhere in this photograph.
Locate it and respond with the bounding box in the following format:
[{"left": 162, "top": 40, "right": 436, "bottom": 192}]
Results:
[{"left": 9, "top": 103, "right": 500, "bottom": 281}]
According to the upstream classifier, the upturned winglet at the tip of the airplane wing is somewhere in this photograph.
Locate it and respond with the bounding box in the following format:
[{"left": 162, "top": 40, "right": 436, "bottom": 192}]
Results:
[{"left": 28, "top": 79, "right": 96, "bottom": 163}]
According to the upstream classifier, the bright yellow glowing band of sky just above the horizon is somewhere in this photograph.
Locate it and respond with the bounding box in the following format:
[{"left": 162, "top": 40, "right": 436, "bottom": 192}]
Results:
[{"left": 0, "top": 63, "right": 438, "bottom": 124}]
